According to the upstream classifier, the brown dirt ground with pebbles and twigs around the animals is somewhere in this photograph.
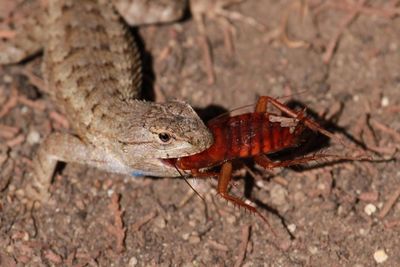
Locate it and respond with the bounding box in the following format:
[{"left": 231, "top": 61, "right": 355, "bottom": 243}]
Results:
[{"left": 0, "top": 0, "right": 400, "bottom": 267}]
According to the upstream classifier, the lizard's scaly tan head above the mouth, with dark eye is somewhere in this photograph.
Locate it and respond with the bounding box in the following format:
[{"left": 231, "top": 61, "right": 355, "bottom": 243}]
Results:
[{"left": 115, "top": 101, "right": 214, "bottom": 159}]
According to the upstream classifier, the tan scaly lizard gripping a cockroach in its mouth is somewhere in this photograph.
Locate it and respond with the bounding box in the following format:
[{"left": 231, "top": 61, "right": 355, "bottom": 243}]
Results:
[{"left": 0, "top": 0, "right": 213, "bottom": 201}]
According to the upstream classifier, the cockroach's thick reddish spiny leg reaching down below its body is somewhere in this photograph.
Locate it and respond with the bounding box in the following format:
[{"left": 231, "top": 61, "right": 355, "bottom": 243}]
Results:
[{"left": 217, "top": 162, "right": 276, "bottom": 236}]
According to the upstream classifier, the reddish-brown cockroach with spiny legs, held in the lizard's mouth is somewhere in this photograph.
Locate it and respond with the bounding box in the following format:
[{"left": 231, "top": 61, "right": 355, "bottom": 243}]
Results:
[{"left": 165, "top": 96, "right": 348, "bottom": 232}]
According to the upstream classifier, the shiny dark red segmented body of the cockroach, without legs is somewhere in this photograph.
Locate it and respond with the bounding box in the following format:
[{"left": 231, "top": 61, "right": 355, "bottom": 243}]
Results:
[{"left": 178, "top": 112, "right": 303, "bottom": 169}]
